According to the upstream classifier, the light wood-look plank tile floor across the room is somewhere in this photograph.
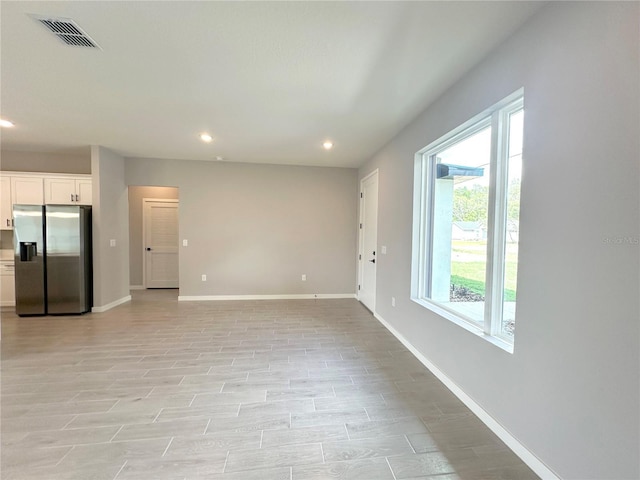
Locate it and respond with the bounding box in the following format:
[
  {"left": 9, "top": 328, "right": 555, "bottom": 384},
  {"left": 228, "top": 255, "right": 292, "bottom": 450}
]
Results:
[{"left": 0, "top": 290, "right": 537, "bottom": 480}]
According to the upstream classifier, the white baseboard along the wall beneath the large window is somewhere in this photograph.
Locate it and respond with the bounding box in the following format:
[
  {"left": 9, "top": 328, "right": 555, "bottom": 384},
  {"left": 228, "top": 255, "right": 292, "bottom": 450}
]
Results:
[{"left": 373, "top": 313, "right": 560, "bottom": 480}]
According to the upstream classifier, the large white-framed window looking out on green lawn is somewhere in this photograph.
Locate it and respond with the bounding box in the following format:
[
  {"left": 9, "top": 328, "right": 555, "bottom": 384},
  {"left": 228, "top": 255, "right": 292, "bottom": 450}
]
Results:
[{"left": 412, "top": 91, "right": 524, "bottom": 351}]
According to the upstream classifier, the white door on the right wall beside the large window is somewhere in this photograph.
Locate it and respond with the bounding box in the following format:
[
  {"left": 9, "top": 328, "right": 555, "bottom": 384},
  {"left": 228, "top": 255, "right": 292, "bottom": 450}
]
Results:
[{"left": 358, "top": 170, "right": 378, "bottom": 312}]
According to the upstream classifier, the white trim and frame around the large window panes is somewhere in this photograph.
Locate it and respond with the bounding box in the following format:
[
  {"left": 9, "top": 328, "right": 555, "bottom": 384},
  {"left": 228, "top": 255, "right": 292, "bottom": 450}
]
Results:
[{"left": 411, "top": 89, "right": 524, "bottom": 353}]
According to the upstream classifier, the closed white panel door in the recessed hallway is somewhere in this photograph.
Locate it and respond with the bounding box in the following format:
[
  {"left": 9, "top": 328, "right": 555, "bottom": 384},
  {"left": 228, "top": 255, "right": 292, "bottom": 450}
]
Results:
[{"left": 142, "top": 198, "right": 178, "bottom": 288}]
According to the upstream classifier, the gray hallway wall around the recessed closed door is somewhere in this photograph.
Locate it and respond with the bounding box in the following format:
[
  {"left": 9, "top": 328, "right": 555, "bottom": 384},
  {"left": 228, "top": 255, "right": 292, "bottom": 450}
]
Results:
[{"left": 129, "top": 186, "right": 178, "bottom": 286}]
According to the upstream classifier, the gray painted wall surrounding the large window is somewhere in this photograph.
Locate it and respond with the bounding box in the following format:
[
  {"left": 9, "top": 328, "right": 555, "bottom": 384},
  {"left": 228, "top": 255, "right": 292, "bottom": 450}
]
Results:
[{"left": 359, "top": 2, "right": 640, "bottom": 479}]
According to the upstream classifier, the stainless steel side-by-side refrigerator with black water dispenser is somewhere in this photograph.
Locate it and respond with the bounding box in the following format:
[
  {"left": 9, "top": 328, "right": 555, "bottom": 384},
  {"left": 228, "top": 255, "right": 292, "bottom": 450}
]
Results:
[{"left": 13, "top": 205, "right": 93, "bottom": 316}]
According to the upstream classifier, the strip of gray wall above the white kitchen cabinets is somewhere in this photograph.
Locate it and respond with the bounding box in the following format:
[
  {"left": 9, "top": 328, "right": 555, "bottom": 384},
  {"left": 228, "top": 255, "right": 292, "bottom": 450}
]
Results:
[{"left": 0, "top": 150, "right": 91, "bottom": 173}]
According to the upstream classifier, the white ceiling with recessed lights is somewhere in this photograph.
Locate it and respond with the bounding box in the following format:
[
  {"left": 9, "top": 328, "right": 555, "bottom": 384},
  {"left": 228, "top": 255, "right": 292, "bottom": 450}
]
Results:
[{"left": 0, "top": 0, "right": 542, "bottom": 167}]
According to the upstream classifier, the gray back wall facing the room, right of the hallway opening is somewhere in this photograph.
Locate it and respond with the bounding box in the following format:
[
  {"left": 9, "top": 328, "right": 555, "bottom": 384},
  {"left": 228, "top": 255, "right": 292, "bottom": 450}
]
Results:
[{"left": 126, "top": 158, "right": 357, "bottom": 296}]
